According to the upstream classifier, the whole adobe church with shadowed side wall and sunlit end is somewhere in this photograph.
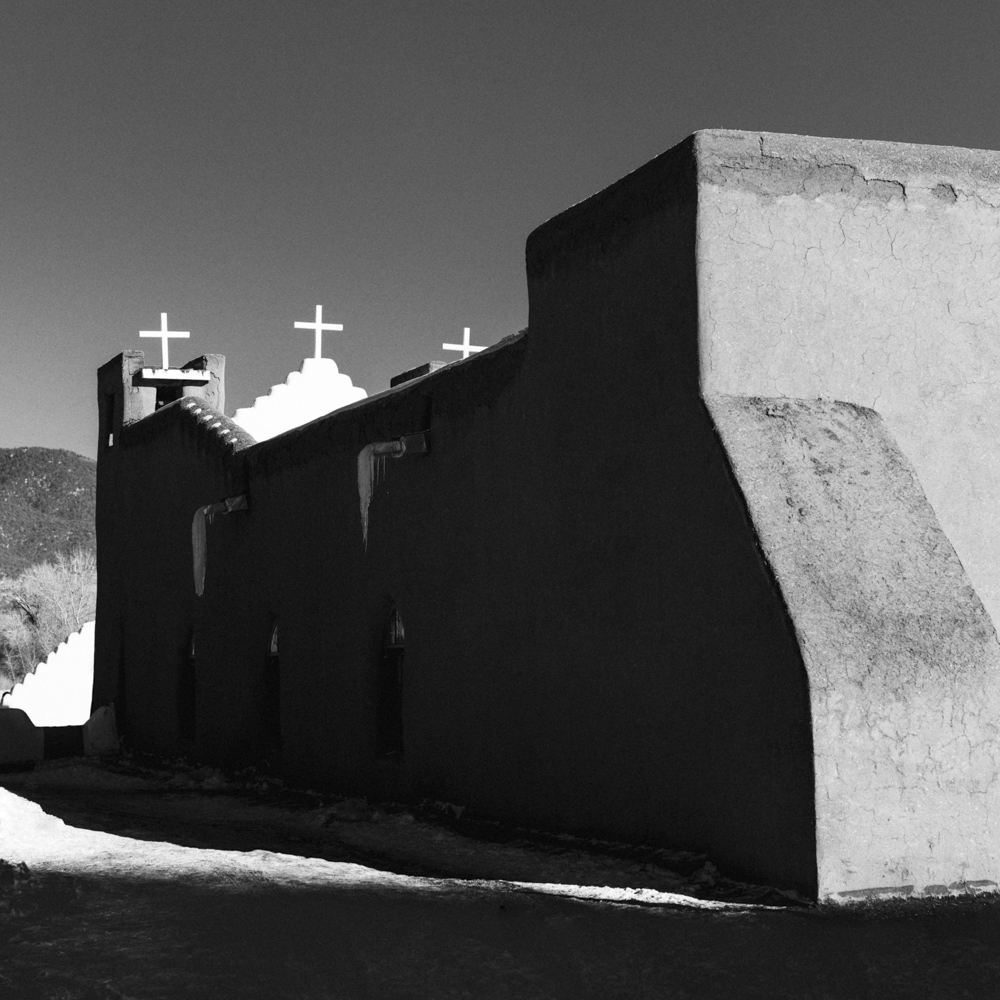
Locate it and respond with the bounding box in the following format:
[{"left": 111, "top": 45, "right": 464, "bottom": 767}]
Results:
[{"left": 93, "top": 131, "right": 1000, "bottom": 900}]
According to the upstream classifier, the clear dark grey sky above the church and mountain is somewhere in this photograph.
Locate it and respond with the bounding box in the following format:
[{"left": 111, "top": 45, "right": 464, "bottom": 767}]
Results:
[{"left": 0, "top": 0, "right": 1000, "bottom": 456}]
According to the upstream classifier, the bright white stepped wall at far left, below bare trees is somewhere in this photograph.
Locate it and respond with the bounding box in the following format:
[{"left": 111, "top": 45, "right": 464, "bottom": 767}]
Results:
[{"left": 3, "top": 622, "right": 94, "bottom": 726}]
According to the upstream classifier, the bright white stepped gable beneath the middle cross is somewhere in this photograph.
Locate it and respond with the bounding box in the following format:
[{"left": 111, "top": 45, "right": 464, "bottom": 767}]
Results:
[{"left": 233, "top": 358, "right": 368, "bottom": 441}]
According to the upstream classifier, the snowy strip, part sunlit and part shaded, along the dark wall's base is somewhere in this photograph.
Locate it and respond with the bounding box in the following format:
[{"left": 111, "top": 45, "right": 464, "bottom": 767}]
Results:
[{"left": 0, "top": 758, "right": 796, "bottom": 908}]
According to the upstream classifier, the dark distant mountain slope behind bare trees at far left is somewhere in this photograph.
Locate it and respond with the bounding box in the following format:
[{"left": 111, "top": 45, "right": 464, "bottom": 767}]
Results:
[{"left": 0, "top": 448, "right": 97, "bottom": 576}]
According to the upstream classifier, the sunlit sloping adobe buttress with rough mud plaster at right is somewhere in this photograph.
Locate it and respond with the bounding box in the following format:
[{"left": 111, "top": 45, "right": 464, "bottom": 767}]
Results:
[{"left": 709, "top": 397, "right": 1000, "bottom": 898}]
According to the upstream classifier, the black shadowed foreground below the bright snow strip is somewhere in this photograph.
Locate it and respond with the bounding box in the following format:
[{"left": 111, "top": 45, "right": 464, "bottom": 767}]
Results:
[{"left": 0, "top": 875, "right": 1000, "bottom": 1000}]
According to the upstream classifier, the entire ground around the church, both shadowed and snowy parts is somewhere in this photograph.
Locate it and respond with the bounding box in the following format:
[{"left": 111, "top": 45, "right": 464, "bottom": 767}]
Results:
[{"left": 0, "top": 758, "right": 1000, "bottom": 1000}]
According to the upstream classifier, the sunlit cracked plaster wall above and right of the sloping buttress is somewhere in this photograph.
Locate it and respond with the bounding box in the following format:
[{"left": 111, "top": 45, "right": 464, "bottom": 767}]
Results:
[{"left": 697, "top": 133, "right": 1000, "bottom": 622}]
